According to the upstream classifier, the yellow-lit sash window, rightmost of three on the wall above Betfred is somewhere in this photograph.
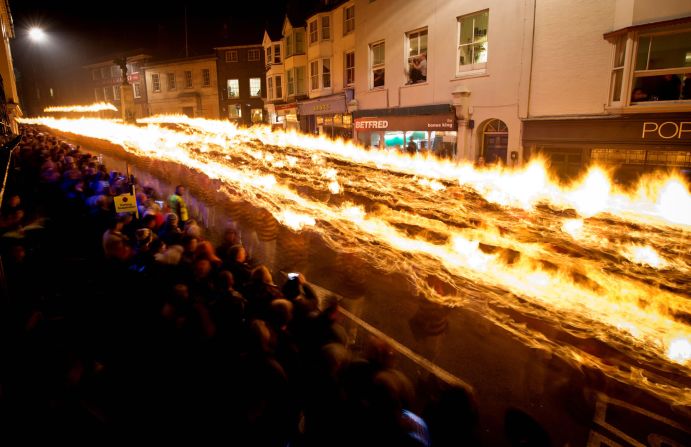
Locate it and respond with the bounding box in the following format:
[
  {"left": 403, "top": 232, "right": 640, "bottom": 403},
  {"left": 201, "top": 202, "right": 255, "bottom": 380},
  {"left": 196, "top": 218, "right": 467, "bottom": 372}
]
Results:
[{"left": 456, "top": 11, "right": 489, "bottom": 73}]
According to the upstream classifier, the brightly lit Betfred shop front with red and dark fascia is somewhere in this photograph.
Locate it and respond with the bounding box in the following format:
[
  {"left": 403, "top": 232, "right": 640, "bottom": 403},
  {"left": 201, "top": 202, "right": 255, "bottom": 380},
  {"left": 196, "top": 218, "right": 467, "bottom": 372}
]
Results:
[{"left": 354, "top": 111, "right": 457, "bottom": 159}]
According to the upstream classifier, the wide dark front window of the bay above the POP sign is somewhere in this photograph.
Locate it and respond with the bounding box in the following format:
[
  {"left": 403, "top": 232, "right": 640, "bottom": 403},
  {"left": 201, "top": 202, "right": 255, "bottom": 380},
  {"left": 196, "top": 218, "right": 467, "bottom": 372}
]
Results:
[{"left": 632, "top": 29, "right": 691, "bottom": 103}]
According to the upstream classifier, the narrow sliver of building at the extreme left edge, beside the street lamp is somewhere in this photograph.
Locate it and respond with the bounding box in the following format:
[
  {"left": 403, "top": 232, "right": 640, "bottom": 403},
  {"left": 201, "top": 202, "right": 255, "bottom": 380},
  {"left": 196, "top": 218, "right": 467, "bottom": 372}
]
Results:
[{"left": 0, "top": 0, "right": 22, "bottom": 134}]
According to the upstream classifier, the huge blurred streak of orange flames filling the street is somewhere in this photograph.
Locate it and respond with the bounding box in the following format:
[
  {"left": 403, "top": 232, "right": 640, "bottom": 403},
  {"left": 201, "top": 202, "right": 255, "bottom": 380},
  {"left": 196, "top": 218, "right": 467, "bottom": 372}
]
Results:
[{"left": 23, "top": 116, "right": 691, "bottom": 404}]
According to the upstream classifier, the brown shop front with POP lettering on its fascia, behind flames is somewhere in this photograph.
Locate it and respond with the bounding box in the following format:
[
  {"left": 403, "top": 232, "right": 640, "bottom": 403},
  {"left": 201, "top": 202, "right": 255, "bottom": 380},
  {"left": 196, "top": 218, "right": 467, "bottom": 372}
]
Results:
[{"left": 523, "top": 113, "right": 691, "bottom": 182}]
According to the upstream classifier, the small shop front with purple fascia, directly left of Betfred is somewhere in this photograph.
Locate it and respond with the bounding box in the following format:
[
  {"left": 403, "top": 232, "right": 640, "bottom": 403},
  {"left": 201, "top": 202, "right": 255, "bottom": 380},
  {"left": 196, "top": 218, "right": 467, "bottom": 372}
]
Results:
[{"left": 298, "top": 94, "right": 353, "bottom": 139}]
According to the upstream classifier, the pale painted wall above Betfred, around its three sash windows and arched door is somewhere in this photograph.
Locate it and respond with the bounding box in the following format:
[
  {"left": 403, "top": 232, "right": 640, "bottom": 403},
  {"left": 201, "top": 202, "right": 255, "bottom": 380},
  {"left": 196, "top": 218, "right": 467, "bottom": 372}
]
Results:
[{"left": 355, "top": 0, "right": 534, "bottom": 158}]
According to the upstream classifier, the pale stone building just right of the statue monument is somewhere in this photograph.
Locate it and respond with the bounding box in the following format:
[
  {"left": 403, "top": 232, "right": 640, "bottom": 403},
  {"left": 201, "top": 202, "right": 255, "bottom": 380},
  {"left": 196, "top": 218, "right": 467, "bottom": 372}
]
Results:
[{"left": 144, "top": 55, "right": 220, "bottom": 119}]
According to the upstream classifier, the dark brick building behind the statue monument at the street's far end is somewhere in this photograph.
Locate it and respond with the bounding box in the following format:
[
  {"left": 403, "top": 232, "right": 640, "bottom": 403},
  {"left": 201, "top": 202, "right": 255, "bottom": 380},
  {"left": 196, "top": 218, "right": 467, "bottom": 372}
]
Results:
[{"left": 84, "top": 53, "right": 151, "bottom": 117}]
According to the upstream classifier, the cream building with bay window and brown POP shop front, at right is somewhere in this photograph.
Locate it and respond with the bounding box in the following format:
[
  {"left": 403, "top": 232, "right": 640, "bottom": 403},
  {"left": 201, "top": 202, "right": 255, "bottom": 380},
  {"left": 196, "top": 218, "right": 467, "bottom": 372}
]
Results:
[{"left": 523, "top": 0, "right": 691, "bottom": 180}]
